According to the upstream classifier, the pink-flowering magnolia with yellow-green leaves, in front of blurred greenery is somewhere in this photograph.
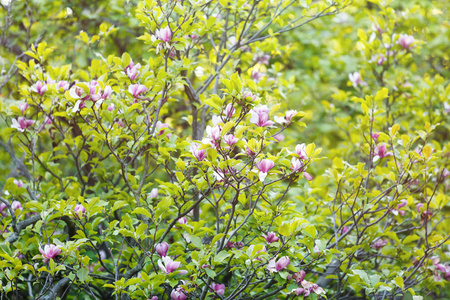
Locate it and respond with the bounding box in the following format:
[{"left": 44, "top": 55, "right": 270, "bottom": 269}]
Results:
[{"left": 0, "top": 0, "right": 450, "bottom": 300}]
